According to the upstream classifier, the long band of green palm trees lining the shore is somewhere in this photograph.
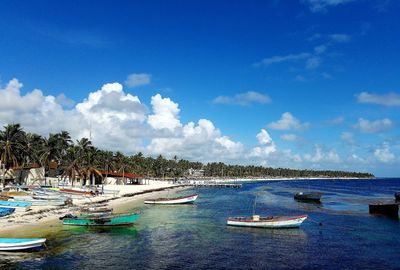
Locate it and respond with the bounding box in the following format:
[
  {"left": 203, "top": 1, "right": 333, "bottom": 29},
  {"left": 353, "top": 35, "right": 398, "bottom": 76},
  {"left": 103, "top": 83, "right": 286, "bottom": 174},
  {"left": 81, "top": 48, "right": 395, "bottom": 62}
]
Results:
[{"left": 0, "top": 124, "right": 373, "bottom": 179}]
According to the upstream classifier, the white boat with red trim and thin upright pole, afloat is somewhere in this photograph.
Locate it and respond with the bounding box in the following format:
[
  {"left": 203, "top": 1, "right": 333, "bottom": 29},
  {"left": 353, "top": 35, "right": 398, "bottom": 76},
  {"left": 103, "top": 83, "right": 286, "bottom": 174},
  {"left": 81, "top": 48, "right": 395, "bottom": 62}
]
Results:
[{"left": 227, "top": 215, "right": 307, "bottom": 229}]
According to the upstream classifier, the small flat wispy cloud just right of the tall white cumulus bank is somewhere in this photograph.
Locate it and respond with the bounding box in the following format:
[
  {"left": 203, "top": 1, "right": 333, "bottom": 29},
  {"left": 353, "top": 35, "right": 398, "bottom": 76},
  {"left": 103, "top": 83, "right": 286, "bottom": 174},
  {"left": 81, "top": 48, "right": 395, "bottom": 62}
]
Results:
[{"left": 213, "top": 91, "right": 271, "bottom": 106}]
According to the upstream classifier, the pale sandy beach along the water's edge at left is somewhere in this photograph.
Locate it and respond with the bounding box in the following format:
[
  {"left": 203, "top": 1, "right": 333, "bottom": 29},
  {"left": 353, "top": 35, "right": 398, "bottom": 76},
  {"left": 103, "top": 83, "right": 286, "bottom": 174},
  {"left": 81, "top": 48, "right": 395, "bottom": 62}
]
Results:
[{"left": 0, "top": 181, "right": 184, "bottom": 237}]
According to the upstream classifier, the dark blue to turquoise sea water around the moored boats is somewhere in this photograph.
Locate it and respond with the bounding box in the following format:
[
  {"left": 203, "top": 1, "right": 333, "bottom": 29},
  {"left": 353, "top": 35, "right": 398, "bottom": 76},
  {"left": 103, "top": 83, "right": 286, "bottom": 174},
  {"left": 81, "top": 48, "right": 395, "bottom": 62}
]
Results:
[{"left": 0, "top": 179, "right": 400, "bottom": 269}]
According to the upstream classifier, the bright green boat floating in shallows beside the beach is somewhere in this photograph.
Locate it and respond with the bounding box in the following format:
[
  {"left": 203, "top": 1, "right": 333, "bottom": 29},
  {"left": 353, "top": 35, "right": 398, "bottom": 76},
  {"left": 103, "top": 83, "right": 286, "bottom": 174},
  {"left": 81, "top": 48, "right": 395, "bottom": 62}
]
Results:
[{"left": 63, "top": 213, "right": 140, "bottom": 227}]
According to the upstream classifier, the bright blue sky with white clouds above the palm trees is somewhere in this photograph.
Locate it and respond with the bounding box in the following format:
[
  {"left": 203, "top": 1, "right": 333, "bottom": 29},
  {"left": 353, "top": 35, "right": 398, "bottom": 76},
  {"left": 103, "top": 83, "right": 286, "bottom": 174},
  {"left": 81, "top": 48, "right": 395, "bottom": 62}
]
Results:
[{"left": 0, "top": 0, "right": 400, "bottom": 176}]
